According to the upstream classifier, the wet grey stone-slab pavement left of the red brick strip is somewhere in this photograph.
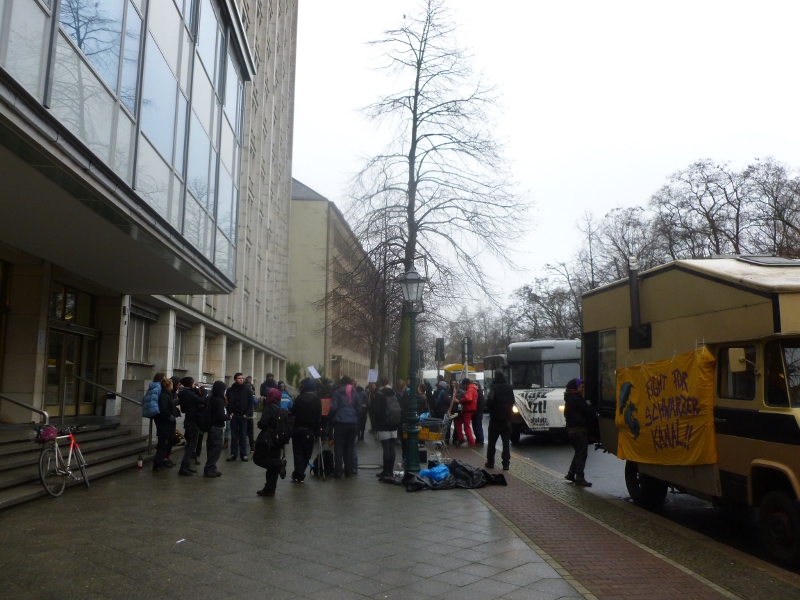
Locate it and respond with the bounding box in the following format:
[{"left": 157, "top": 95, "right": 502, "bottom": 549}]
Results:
[{"left": 0, "top": 439, "right": 581, "bottom": 600}]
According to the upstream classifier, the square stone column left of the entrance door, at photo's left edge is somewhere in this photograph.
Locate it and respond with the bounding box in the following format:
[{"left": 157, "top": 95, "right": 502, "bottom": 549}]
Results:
[{"left": 0, "top": 261, "right": 51, "bottom": 423}]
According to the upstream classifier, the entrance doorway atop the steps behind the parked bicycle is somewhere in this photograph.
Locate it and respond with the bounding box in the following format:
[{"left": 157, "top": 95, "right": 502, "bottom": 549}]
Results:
[{"left": 45, "top": 328, "right": 98, "bottom": 421}]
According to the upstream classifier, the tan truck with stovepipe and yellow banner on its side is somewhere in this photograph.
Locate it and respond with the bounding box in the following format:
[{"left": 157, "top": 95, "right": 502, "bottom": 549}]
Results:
[{"left": 582, "top": 256, "right": 800, "bottom": 564}]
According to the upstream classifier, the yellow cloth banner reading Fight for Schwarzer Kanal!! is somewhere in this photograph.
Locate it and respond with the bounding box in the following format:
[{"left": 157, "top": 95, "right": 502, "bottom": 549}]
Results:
[{"left": 616, "top": 347, "right": 717, "bottom": 465}]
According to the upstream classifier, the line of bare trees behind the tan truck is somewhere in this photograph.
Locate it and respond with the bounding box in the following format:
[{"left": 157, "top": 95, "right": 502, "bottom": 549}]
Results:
[{"left": 438, "top": 157, "right": 800, "bottom": 362}]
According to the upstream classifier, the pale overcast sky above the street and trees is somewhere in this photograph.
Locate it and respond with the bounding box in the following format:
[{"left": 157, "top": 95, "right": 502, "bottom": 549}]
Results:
[{"left": 293, "top": 0, "right": 800, "bottom": 304}]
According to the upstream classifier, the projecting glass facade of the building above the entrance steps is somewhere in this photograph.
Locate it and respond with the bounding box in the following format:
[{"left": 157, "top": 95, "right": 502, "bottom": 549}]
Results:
[{"left": 0, "top": 0, "right": 244, "bottom": 279}]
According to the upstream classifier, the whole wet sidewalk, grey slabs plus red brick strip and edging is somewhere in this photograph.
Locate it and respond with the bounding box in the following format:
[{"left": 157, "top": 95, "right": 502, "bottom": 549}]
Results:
[{"left": 6, "top": 438, "right": 800, "bottom": 600}]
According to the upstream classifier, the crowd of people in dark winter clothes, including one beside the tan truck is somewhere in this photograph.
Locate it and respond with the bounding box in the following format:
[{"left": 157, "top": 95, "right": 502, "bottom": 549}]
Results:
[{"left": 143, "top": 371, "right": 591, "bottom": 496}]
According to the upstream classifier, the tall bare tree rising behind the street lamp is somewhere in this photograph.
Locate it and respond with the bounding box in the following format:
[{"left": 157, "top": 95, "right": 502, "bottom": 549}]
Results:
[{"left": 348, "top": 0, "right": 527, "bottom": 382}]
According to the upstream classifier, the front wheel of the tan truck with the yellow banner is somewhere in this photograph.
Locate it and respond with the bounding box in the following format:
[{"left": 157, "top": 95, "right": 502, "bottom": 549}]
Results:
[{"left": 758, "top": 492, "right": 800, "bottom": 564}]
